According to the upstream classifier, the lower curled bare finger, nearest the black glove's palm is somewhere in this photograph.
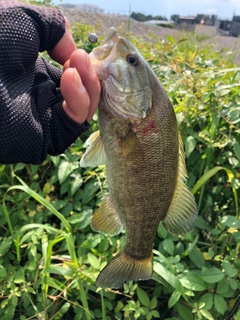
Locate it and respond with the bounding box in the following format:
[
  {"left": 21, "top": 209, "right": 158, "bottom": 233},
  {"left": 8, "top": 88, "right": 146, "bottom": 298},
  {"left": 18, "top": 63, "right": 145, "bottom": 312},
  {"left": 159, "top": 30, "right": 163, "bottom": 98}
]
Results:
[{"left": 60, "top": 68, "right": 90, "bottom": 123}]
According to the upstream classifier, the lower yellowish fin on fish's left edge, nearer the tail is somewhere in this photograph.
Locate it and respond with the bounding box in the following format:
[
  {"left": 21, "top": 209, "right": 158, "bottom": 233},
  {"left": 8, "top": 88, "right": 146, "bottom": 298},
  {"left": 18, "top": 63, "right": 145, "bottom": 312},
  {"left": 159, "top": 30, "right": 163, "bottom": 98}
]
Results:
[{"left": 91, "top": 194, "right": 123, "bottom": 235}]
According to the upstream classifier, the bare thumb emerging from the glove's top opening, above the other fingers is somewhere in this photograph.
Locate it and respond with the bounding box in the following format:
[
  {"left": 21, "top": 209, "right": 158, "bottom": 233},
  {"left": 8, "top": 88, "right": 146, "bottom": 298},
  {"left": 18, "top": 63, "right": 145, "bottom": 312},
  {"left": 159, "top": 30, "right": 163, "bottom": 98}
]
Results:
[{"left": 48, "top": 18, "right": 76, "bottom": 65}]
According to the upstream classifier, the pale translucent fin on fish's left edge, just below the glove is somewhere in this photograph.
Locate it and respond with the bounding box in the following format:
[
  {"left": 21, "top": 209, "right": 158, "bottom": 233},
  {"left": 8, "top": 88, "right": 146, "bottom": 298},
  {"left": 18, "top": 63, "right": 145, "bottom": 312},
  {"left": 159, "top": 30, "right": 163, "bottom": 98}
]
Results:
[{"left": 80, "top": 130, "right": 106, "bottom": 168}]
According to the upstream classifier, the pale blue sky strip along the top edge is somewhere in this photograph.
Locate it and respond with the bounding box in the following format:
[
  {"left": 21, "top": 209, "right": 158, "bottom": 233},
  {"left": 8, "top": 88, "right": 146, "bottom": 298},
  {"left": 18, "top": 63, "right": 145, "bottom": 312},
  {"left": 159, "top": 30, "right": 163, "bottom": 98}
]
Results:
[{"left": 53, "top": 0, "right": 240, "bottom": 20}]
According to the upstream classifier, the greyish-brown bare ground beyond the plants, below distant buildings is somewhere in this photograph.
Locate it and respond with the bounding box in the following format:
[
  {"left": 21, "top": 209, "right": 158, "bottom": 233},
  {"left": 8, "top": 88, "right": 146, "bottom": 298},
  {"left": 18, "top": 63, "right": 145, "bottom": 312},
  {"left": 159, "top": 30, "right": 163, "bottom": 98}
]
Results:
[{"left": 61, "top": 8, "right": 240, "bottom": 64}]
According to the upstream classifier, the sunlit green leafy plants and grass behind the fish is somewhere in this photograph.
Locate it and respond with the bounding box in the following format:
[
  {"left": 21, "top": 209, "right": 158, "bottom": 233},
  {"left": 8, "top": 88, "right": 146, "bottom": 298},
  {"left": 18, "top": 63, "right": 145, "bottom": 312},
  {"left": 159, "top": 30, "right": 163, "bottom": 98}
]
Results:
[{"left": 0, "top": 24, "right": 240, "bottom": 320}]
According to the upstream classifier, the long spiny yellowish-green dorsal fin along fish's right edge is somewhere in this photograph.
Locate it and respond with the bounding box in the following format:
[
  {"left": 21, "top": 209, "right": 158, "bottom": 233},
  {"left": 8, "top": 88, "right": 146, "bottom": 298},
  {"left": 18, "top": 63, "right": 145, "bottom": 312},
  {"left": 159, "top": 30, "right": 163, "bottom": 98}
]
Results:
[{"left": 163, "top": 133, "right": 198, "bottom": 235}]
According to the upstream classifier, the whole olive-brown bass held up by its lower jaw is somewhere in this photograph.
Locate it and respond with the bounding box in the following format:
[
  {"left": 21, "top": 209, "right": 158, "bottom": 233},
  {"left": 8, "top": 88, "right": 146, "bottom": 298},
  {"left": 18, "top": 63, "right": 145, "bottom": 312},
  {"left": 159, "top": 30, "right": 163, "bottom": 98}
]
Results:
[{"left": 80, "top": 27, "right": 198, "bottom": 289}]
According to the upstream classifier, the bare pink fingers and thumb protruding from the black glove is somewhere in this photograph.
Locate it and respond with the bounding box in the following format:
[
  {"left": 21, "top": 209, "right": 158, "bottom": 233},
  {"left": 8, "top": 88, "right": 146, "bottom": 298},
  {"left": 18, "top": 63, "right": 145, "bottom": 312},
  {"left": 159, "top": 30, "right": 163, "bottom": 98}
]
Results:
[{"left": 48, "top": 18, "right": 101, "bottom": 123}]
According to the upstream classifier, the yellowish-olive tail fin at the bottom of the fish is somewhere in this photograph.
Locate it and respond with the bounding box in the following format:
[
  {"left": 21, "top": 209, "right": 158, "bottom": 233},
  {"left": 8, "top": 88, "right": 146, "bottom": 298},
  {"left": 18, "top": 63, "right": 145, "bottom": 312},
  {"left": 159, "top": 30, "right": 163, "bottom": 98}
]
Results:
[{"left": 96, "top": 249, "right": 153, "bottom": 289}]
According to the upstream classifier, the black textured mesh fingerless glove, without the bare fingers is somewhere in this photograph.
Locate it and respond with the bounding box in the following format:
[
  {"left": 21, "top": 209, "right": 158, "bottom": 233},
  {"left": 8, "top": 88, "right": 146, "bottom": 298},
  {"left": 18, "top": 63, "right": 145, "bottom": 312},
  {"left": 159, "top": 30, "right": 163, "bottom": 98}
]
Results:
[{"left": 0, "top": 1, "right": 89, "bottom": 164}]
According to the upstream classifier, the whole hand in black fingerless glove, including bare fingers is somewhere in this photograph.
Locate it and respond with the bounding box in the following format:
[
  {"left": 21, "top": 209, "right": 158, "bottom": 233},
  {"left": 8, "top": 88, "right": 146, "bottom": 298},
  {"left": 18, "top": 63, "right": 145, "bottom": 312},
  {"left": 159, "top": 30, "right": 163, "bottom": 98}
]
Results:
[{"left": 0, "top": 1, "right": 100, "bottom": 164}]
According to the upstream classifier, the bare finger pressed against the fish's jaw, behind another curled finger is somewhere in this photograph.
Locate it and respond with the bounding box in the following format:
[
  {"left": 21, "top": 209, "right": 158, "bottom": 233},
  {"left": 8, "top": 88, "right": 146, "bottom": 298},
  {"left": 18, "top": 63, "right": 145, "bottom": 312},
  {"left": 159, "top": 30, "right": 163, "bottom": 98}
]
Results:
[{"left": 70, "top": 49, "right": 101, "bottom": 121}]
